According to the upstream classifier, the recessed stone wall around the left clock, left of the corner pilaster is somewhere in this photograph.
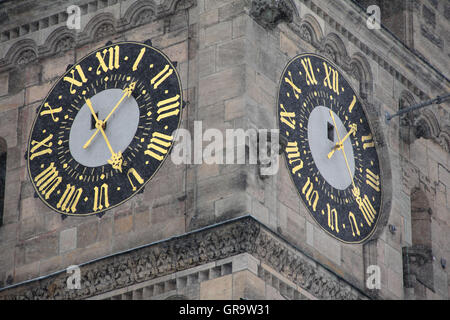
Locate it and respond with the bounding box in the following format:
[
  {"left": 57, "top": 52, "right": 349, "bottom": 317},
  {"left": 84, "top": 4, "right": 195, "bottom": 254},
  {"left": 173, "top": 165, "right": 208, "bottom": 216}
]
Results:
[{"left": 0, "top": 1, "right": 195, "bottom": 286}]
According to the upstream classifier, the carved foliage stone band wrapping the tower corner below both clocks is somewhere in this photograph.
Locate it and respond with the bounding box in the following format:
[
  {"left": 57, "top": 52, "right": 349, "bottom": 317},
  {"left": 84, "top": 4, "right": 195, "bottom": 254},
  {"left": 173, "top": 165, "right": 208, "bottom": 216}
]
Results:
[{"left": 0, "top": 216, "right": 368, "bottom": 300}]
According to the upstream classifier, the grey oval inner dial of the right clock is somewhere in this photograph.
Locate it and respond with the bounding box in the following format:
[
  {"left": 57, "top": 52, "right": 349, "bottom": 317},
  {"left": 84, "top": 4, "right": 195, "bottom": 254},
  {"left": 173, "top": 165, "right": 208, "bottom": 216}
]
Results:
[{"left": 308, "top": 106, "right": 355, "bottom": 190}]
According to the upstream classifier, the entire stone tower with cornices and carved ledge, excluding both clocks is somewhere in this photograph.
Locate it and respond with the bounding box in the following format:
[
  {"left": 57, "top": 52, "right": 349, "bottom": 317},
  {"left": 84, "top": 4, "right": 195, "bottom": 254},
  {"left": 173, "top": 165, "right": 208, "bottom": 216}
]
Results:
[{"left": 0, "top": 0, "right": 450, "bottom": 300}]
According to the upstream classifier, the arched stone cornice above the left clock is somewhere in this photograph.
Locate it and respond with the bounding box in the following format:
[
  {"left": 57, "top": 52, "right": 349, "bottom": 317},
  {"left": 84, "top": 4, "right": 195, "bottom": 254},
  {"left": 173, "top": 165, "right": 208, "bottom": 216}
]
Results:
[{"left": 0, "top": 0, "right": 192, "bottom": 72}]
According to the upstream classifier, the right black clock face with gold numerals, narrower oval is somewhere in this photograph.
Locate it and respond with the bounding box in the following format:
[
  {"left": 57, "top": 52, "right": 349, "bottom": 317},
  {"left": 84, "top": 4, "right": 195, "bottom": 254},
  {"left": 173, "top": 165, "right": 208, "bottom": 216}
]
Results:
[{"left": 277, "top": 54, "right": 382, "bottom": 243}]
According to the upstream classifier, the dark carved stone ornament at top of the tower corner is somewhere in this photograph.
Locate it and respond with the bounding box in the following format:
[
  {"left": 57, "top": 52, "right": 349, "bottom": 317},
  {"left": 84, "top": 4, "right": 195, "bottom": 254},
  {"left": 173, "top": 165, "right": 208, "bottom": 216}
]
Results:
[{"left": 250, "top": 0, "right": 293, "bottom": 29}]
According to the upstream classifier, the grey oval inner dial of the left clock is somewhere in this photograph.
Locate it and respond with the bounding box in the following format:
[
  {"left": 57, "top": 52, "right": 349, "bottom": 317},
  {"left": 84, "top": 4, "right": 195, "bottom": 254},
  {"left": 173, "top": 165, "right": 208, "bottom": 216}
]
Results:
[{"left": 69, "top": 89, "right": 139, "bottom": 167}]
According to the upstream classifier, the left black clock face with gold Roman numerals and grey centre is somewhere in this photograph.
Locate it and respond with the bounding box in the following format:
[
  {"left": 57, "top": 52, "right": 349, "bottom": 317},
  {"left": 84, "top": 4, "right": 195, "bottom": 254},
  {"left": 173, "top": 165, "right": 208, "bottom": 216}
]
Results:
[{"left": 27, "top": 42, "right": 183, "bottom": 215}]
